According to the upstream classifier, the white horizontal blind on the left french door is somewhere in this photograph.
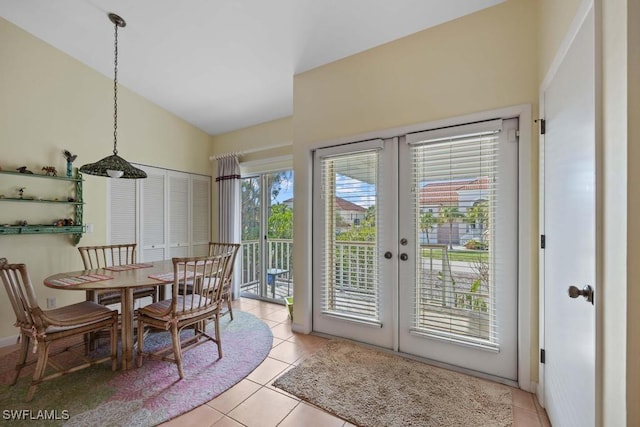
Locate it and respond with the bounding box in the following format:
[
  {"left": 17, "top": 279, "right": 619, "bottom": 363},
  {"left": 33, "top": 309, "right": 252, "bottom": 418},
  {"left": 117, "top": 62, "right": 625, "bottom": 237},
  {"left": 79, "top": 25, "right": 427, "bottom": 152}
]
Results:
[{"left": 316, "top": 140, "right": 382, "bottom": 323}]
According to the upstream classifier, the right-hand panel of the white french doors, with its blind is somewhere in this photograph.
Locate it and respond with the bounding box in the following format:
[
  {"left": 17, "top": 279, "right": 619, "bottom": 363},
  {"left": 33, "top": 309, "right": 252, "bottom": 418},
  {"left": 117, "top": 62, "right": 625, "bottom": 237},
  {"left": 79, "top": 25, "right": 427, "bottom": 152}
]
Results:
[{"left": 398, "top": 119, "right": 518, "bottom": 381}]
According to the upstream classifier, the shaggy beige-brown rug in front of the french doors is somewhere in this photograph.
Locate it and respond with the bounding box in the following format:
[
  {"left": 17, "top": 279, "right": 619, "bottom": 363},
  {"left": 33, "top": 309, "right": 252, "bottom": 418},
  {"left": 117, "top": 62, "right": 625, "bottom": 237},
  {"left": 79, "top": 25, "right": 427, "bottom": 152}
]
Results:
[{"left": 273, "top": 340, "right": 513, "bottom": 427}]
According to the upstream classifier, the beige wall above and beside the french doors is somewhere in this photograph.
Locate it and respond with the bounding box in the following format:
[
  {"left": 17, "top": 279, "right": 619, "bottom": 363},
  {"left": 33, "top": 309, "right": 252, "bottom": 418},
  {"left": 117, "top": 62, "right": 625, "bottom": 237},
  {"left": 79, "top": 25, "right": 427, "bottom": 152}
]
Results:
[{"left": 293, "top": 0, "right": 538, "bottom": 381}]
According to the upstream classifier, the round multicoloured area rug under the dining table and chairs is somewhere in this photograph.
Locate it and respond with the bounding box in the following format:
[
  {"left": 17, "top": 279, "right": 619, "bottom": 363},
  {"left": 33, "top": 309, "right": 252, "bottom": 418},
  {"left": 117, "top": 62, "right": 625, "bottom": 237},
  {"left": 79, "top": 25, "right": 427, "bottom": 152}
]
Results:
[{"left": 0, "top": 310, "right": 273, "bottom": 426}]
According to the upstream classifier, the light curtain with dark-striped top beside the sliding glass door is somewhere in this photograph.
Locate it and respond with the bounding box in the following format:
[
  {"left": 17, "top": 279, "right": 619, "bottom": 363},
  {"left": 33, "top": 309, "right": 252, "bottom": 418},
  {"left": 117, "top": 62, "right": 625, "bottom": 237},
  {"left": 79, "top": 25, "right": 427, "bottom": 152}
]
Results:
[{"left": 216, "top": 154, "right": 242, "bottom": 298}]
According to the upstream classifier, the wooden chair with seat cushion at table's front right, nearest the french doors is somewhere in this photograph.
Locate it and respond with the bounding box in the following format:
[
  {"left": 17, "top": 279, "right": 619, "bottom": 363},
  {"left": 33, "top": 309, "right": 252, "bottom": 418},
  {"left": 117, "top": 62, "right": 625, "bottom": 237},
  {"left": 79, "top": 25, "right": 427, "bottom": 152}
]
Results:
[{"left": 137, "top": 252, "right": 233, "bottom": 378}]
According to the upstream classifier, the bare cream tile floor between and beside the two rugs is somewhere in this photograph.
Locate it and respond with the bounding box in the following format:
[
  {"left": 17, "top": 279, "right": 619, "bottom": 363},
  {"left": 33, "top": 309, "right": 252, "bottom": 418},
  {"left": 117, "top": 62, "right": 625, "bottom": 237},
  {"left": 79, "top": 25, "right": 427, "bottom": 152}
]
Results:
[{"left": 161, "top": 298, "right": 551, "bottom": 427}]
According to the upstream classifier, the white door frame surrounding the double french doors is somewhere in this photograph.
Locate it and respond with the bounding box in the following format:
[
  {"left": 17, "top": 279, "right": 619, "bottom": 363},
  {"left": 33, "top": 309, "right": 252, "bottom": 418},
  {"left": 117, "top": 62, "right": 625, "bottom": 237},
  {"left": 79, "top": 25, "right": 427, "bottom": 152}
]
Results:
[{"left": 302, "top": 104, "right": 538, "bottom": 392}]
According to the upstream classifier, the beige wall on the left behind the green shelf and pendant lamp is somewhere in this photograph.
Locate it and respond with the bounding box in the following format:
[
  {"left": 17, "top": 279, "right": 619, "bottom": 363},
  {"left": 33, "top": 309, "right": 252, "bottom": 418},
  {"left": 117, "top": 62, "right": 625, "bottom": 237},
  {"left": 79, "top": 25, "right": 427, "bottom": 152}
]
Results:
[{"left": 0, "top": 18, "right": 211, "bottom": 339}]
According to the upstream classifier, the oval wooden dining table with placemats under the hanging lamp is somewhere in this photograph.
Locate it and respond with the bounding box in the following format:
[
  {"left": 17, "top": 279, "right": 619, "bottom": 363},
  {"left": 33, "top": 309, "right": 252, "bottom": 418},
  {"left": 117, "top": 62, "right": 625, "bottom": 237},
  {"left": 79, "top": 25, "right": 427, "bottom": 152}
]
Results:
[{"left": 44, "top": 259, "right": 173, "bottom": 370}]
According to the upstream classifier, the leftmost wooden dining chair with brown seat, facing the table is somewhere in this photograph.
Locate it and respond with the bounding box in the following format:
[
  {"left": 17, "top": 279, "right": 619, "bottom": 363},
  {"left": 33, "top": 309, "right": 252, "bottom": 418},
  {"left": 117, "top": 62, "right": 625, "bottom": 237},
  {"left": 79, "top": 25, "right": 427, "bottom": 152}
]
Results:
[{"left": 0, "top": 263, "right": 118, "bottom": 402}]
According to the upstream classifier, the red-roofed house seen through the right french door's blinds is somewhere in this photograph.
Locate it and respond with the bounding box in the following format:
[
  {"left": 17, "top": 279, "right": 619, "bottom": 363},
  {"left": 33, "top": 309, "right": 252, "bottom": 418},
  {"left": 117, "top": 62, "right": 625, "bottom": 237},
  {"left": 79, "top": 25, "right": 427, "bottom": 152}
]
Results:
[{"left": 420, "top": 177, "right": 489, "bottom": 245}]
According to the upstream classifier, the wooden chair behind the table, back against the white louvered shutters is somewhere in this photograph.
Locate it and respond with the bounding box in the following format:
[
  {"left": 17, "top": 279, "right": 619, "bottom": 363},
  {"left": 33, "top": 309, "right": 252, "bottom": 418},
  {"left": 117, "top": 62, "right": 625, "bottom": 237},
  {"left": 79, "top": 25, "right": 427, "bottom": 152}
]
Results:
[{"left": 78, "top": 243, "right": 158, "bottom": 305}]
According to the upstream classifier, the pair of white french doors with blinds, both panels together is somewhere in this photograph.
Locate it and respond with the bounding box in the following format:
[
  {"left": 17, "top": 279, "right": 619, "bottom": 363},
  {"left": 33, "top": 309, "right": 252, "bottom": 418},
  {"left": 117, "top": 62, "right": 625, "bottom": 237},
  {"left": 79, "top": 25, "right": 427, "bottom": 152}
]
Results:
[{"left": 313, "top": 119, "right": 518, "bottom": 380}]
